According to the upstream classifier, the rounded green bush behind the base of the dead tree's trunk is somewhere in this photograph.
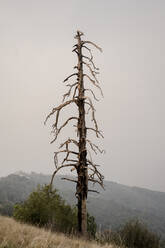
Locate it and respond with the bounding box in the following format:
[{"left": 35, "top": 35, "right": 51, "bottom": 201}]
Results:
[{"left": 13, "top": 185, "right": 96, "bottom": 237}]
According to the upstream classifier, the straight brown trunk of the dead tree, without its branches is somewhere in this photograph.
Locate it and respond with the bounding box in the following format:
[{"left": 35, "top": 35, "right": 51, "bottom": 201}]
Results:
[{"left": 77, "top": 32, "right": 88, "bottom": 236}]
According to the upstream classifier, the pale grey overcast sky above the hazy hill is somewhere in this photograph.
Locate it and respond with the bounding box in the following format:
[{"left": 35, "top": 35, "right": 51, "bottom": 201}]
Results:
[{"left": 0, "top": 0, "right": 165, "bottom": 191}]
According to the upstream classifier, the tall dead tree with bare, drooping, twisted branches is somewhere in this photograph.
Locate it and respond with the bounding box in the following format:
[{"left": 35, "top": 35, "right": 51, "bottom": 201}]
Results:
[{"left": 45, "top": 31, "right": 104, "bottom": 236}]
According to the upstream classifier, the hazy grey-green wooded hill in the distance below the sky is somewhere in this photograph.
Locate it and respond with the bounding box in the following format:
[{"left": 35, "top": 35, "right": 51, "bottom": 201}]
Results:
[{"left": 0, "top": 172, "right": 165, "bottom": 239}]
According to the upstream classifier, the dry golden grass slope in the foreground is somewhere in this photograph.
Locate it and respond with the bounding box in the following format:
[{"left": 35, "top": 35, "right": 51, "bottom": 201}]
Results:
[{"left": 0, "top": 216, "right": 119, "bottom": 248}]
